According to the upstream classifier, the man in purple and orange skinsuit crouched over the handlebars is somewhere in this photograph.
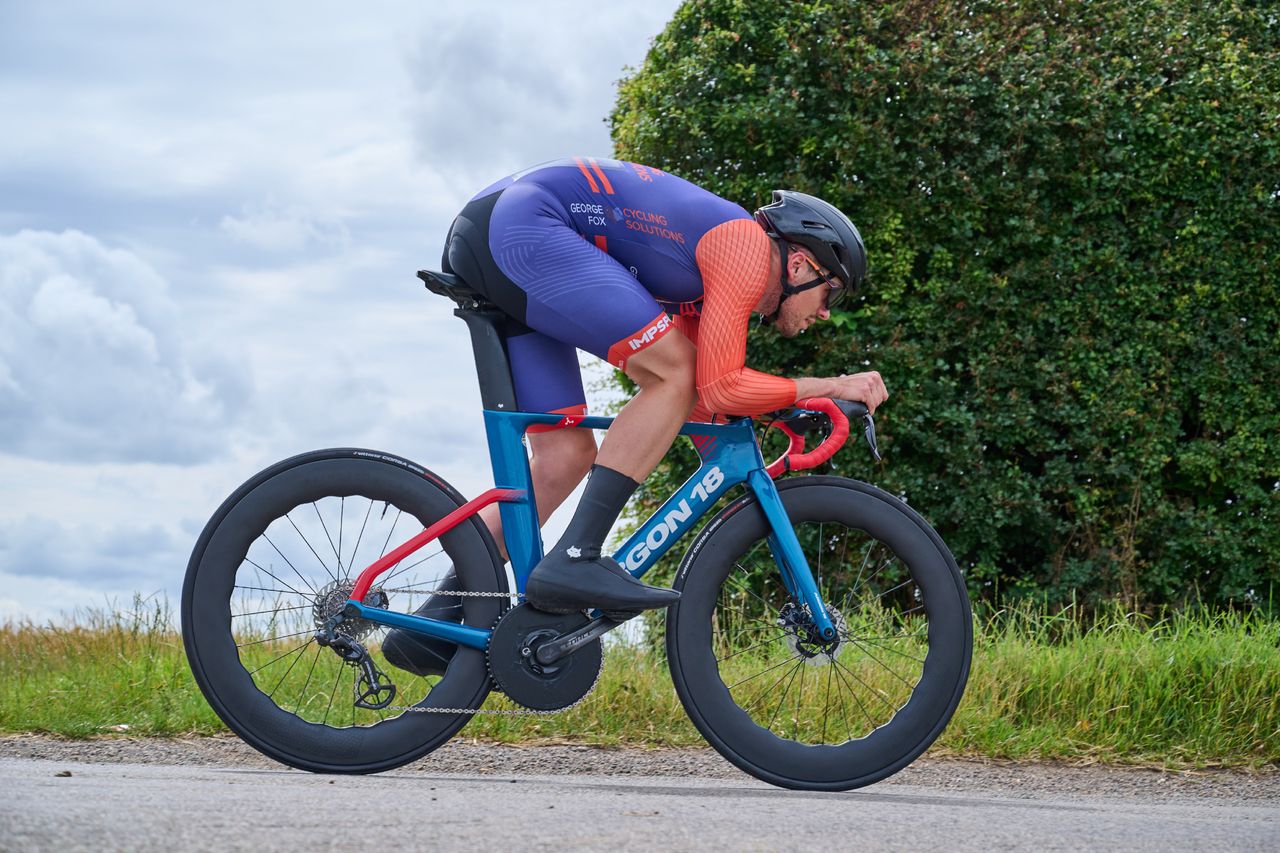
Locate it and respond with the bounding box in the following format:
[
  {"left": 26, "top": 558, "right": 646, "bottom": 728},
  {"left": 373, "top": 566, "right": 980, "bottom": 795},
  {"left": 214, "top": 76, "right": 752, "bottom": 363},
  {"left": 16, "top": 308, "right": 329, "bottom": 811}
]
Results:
[{"left": 383, "top": 158, "right": 888, "bottom": 672}]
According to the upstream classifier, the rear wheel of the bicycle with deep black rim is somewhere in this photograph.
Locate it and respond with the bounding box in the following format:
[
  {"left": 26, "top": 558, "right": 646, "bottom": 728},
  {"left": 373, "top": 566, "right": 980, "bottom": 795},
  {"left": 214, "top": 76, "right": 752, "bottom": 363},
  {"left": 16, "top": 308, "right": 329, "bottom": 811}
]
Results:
[{"left": 182, "top": 448, "right": 509, "bottom": 774}]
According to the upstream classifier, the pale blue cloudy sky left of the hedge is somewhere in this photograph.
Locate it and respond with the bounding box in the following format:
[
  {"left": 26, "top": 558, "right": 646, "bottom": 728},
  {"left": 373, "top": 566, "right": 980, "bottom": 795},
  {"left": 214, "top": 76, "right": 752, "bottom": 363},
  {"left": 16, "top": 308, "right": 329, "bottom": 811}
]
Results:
[{"left": 0, "top": 0, "right": 678, "bottom": 622}]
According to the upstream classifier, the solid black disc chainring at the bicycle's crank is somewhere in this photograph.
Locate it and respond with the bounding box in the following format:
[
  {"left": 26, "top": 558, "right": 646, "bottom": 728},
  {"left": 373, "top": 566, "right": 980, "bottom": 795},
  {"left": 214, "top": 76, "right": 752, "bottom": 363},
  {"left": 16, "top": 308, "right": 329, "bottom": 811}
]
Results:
[{"left": 486, "top": 605, "right": 604, "bottom": 711}]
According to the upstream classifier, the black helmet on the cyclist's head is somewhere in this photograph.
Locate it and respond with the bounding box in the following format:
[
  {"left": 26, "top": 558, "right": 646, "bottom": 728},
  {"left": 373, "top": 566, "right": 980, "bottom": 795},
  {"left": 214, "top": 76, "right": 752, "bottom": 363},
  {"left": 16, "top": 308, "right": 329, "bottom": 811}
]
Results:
[{"left": 755, "top": 190, "right": 867, "bottom": 291}]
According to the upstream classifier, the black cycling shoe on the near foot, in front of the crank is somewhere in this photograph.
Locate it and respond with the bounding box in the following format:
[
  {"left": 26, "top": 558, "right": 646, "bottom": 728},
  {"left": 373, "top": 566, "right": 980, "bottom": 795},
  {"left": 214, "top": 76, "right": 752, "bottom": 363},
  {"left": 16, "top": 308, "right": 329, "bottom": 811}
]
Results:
[{"left": 525, "top": 547, "right": 680, "bottom": 619}]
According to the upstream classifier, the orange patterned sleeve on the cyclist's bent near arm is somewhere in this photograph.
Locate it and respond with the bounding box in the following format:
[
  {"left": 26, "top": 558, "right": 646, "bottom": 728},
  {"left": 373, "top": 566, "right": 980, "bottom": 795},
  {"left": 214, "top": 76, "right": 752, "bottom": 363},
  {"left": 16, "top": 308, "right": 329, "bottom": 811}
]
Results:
[{"left": 695, "top": 219, "right": 796, "bottom": 415}]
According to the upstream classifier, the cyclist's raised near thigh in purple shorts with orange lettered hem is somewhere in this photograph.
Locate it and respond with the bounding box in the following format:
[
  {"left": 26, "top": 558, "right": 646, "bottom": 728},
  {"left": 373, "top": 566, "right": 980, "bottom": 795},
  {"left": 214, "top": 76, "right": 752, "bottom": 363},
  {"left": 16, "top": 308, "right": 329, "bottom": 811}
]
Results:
[{"left": 489, "top": 183, "right": 672, "bottom": 368}]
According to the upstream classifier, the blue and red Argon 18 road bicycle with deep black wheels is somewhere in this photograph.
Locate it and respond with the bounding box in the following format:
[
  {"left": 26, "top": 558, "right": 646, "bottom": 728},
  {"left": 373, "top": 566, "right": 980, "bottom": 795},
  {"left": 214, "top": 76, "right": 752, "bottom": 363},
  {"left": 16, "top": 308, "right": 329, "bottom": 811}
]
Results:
[{"left": 182, "top": 270, "right": 973, "bottom": 790}]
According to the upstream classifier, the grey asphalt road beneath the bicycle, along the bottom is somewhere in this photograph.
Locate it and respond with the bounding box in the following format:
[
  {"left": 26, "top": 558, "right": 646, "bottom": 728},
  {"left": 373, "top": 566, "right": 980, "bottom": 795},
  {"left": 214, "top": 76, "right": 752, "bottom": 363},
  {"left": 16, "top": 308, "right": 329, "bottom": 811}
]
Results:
[{"left": 0, "top": 742, "right": 1280, "bottom": 850}]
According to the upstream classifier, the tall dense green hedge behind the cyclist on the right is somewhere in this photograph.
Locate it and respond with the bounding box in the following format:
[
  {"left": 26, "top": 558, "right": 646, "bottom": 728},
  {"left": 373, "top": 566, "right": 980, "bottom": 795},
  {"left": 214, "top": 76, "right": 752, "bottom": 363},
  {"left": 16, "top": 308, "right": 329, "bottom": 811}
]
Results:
[{"left": 612, "top": 0, "right": 1280, "bottom": 606}]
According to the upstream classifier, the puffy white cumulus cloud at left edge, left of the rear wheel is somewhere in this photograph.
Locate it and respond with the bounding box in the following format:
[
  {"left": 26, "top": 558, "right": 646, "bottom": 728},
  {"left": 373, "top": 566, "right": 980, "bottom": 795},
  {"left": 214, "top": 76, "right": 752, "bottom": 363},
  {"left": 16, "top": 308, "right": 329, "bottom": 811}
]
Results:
[{"left": 0, "top": 231, "right": 250, "bottom": 464}]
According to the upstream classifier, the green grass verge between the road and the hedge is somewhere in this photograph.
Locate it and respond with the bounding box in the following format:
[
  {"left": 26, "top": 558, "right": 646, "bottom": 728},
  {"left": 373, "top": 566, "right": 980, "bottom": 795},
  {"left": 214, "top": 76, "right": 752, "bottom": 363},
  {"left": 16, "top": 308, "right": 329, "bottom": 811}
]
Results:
[{"left": 0, "top": 594, "right": 1280, "bottom": 770}]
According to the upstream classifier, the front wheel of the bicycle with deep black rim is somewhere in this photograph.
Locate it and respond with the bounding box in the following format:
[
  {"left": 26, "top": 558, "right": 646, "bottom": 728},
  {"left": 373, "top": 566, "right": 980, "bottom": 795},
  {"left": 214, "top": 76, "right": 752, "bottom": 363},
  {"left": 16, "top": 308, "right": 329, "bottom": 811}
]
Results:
[{"left": 667, "top": 476, "right": 973, "bottom": 790}]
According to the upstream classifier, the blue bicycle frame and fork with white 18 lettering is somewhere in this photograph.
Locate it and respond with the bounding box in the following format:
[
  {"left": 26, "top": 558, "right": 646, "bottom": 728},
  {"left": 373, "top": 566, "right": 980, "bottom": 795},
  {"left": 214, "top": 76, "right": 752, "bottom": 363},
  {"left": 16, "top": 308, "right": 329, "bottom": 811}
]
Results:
[{"left": 348, "top": 410, "right": 836, "bottom": 640}]
